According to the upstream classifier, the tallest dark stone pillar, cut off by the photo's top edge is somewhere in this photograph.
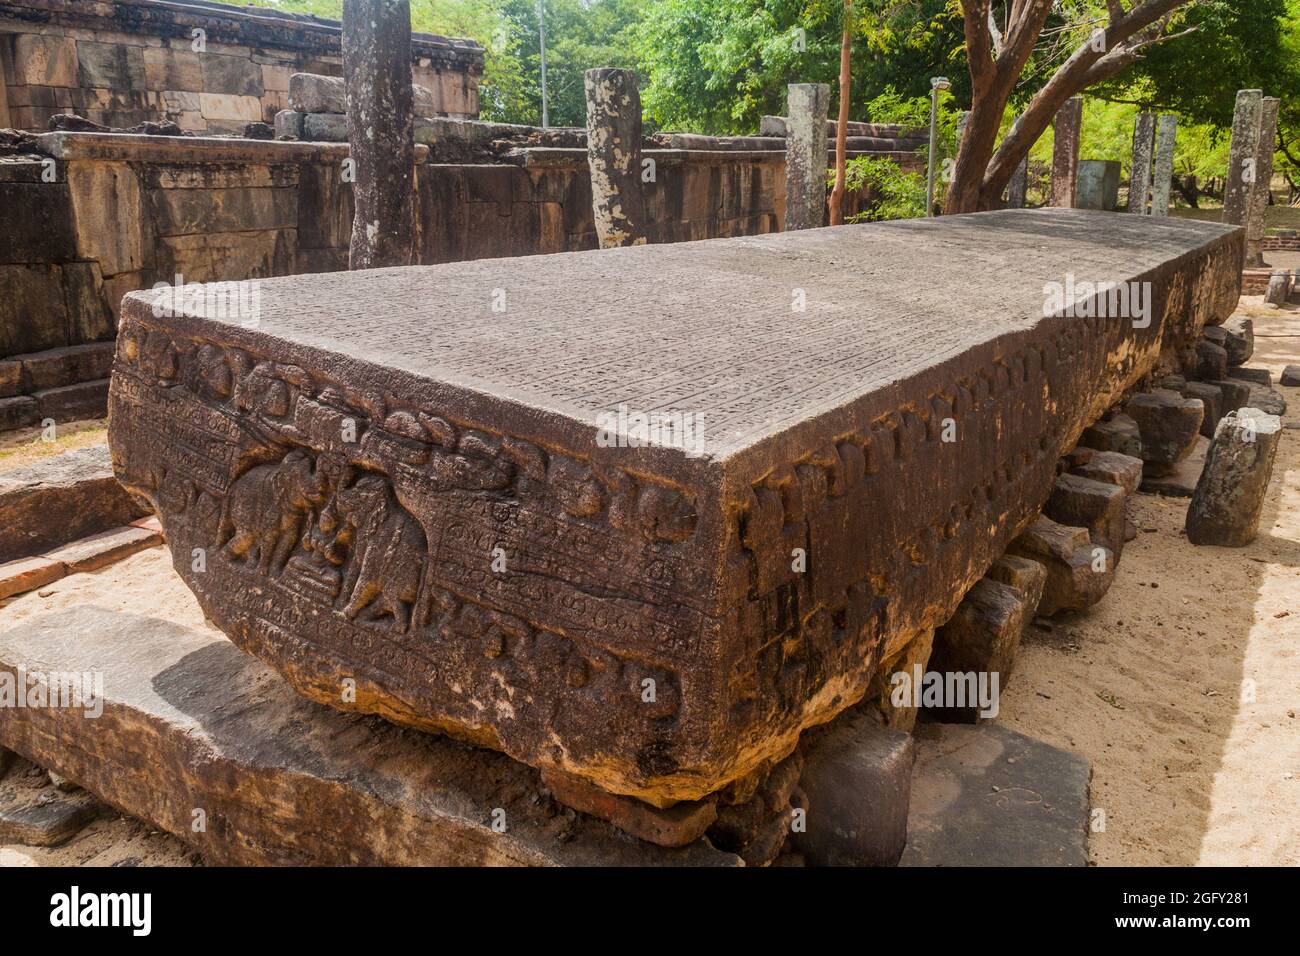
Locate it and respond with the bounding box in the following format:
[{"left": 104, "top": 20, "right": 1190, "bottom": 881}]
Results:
[{"left": 343, "top": 0, "right": 415, "bottom": 269}]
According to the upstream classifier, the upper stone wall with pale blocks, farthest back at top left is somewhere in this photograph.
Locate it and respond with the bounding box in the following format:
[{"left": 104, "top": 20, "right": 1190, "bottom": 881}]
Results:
[{"left": 0, "top": 0, "right": 484, "bottom": 134}]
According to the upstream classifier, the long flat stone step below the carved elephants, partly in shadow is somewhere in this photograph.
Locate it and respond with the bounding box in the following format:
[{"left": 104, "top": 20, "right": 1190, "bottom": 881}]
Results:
[{"left": 0, "top": 606, "right": 738, "bottom": 866}]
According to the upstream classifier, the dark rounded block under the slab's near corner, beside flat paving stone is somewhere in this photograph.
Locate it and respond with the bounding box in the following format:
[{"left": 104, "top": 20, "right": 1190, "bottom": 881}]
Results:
[{"left": 790, "top": 714, "right": 915, "bottom": 866}]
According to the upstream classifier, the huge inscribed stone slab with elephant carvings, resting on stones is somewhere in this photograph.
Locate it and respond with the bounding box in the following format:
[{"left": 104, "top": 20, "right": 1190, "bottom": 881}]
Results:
[{"left": 111, "top": 209, "right": 1243, "bottom": 805}]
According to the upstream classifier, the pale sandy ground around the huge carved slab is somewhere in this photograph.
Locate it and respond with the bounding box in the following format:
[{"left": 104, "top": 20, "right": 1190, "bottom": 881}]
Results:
[{"left": 0, "top": 299, "right": 1300, "bottom": 866}]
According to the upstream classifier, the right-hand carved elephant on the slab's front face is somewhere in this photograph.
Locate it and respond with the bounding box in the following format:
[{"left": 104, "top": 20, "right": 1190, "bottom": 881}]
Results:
[{"left": 334, "top": 475, "right": 426, "bottom": 632}]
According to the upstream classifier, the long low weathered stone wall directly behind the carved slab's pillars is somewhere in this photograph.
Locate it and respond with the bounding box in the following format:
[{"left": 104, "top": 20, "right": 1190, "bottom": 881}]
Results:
[{"left": 0, "top": 133, "right": 785, "bottom": 358}]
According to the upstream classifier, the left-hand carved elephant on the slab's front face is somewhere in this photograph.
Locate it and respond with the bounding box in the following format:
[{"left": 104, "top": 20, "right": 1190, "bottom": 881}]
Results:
[{"left": 217, "top": 451, "right": 326, "bottom": 574}]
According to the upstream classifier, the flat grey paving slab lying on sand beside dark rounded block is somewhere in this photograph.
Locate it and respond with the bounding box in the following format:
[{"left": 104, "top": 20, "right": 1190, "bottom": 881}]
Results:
[{"left": 898, "top": 723, "right": 1092, "bottom": 866}]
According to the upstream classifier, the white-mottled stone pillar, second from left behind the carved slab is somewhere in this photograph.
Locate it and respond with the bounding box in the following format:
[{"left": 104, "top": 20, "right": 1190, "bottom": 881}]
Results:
[{"left": 584, "top": 66, "right": 646, "bottom": 248}]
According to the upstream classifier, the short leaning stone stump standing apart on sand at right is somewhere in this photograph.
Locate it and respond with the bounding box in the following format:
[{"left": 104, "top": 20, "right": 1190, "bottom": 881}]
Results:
[{"left": 1186, "top": 407, "right": 1282, "bottom": 548}]
